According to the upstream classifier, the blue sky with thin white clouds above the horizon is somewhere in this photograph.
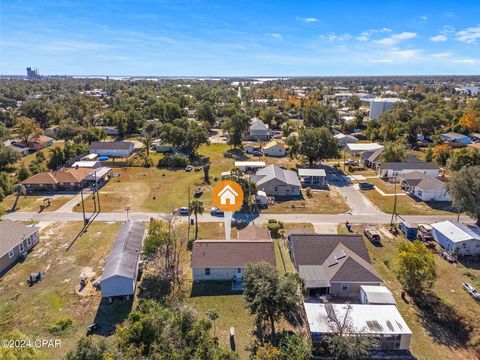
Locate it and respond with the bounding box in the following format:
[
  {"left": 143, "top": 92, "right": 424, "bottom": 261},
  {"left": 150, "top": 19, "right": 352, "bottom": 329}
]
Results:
[{"left": 0, "top": 0, "right": 480, "bottom": 76}]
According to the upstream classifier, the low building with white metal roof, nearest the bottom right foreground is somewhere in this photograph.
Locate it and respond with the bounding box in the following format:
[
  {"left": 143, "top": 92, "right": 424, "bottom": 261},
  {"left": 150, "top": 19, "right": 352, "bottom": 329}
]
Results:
[{"left": 304, "top": 303, "right": 412, "bottom": 351}]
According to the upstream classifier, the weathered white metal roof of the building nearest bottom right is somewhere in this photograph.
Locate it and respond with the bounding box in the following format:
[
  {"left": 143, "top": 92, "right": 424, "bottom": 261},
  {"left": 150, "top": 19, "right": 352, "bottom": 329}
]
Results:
[{"left": 304, "top": 303, "right": 412, "bottom": 335}]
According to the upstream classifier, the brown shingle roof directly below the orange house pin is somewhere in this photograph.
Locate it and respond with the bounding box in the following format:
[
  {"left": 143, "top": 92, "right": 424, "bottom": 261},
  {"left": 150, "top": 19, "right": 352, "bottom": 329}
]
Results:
[{"left": 192, "top": 240, "right": 276, "bottom": 268}]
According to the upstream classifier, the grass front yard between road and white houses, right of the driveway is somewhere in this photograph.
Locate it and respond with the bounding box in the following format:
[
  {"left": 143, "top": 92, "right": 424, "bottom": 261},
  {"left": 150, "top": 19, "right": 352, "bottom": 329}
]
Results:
[{"left": 361, "top": 187, "right": 456, "bottom": 215}]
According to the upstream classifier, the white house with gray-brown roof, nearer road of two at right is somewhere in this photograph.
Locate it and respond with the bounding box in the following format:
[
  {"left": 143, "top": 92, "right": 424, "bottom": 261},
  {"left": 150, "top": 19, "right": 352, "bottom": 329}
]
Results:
[{"left": 399, "top": 171, "right": 451, "bottom": 201}]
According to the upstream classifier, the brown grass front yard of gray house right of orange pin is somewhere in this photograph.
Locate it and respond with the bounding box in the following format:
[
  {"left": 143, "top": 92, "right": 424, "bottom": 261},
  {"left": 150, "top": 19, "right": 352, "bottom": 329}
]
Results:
[{"left": 262, "top": 188, "right": 349, "bottom": 214}]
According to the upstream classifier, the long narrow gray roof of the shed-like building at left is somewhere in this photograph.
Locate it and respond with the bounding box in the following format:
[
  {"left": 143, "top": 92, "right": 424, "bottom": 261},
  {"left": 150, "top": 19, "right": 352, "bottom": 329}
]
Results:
[{"left": 102, "top": 221, "right": 145, "bottom": 280}]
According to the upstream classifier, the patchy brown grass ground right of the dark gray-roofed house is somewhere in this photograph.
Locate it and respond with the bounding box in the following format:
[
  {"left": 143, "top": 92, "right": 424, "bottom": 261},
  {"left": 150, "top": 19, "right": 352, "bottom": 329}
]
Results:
[{"left": 339, "top": 225, "right": 480, "bottom": 360}]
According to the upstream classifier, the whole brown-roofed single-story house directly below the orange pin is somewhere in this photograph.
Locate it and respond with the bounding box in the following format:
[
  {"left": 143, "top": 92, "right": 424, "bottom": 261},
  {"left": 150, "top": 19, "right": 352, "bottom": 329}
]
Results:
[{"left": 191, "top": 240, "right": 276, "bottom": 281}]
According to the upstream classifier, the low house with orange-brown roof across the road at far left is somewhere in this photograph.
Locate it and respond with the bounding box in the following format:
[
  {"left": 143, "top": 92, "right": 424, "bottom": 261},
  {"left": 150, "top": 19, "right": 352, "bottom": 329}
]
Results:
[{"left": 21, "top": 167, "right": 112, "bottom": 193}]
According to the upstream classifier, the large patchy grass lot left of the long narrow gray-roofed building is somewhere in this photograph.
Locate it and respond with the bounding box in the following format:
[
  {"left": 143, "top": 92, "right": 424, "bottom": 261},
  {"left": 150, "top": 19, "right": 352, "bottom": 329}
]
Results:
[{"left": 0, "top": 222, "right": 121, "bottom": 359}]
